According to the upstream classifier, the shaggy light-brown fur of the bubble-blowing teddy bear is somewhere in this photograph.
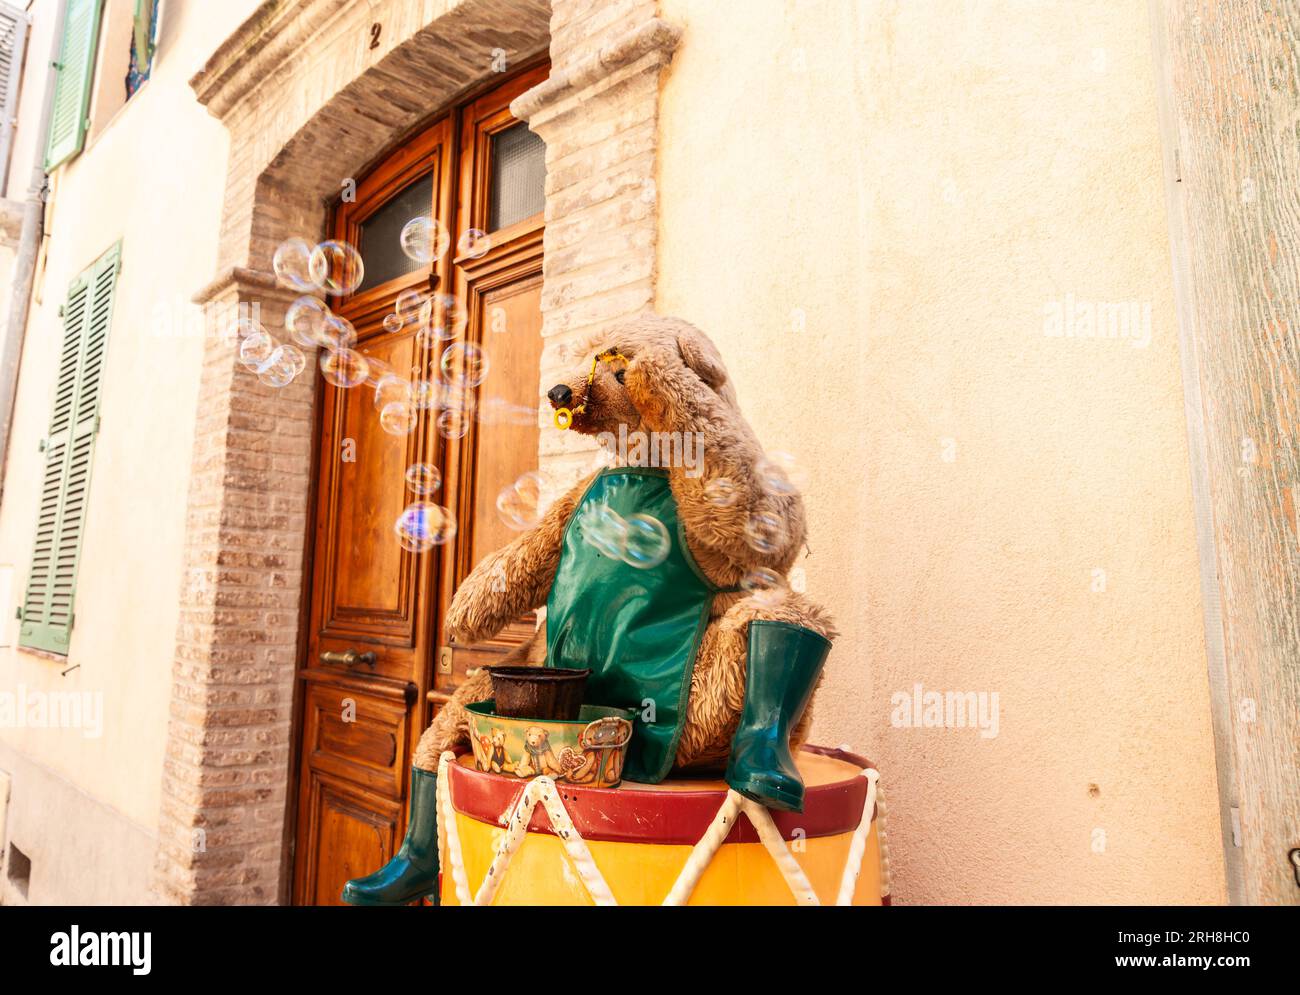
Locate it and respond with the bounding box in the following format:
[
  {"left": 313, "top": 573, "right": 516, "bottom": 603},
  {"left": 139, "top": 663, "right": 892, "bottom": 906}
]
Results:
[{"left": 415, "top": 315, "right": 836, "bottom": 770}]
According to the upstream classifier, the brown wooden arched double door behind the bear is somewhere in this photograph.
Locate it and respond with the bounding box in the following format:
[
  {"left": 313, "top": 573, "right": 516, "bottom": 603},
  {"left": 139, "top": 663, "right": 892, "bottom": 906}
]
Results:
[{"left": 293, "top": 60, "right": 546, "bottom": 904}]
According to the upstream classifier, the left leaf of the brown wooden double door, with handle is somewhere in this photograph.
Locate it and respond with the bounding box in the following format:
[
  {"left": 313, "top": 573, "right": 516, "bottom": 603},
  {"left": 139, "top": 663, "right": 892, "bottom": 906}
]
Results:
[{"left": 294, "top": 117, "right": 454, "bottom": 904}]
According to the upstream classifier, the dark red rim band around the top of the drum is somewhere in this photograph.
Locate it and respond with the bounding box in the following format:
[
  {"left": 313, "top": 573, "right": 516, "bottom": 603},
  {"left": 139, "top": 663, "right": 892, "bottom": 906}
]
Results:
[{"left": 447, "top": 744, "right": 876, "bottom": 847}]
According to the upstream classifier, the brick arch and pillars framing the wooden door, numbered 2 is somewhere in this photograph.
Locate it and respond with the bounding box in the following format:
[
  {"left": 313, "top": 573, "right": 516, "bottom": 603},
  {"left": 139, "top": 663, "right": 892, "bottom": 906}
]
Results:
[{"left": 155, "top": 0, "right": 680, "bottom": 904}]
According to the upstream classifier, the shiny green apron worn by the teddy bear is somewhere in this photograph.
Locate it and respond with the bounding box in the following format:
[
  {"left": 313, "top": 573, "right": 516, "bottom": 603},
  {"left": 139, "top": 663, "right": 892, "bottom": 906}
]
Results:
[{"left": 546, "top": 467, "right": 719, "bottom": 784}]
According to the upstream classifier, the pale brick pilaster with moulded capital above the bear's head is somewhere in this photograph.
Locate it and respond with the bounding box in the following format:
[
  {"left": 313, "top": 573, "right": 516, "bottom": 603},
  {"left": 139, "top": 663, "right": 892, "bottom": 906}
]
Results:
[{"left": 511, "top": 0, "right": 677, "bottom": 486}]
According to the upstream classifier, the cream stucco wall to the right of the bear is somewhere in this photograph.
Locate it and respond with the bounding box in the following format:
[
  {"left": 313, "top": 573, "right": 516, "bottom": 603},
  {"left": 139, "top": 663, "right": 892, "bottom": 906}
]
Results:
[{"left": 658, "top": 0, "right": 1225, "bottom": 903}]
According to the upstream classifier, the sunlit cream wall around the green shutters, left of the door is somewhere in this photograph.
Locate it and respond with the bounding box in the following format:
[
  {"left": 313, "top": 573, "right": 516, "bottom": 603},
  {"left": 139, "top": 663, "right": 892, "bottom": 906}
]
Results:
[{"left": 0, "top": 0, "right": 256, "bottom": 853}]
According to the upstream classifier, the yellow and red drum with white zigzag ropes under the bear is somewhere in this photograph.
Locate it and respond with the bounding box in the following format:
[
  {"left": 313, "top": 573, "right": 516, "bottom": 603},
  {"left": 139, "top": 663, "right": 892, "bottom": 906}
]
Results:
[{"left": 438, "top": 745, "right": 889, "bottom": 905}]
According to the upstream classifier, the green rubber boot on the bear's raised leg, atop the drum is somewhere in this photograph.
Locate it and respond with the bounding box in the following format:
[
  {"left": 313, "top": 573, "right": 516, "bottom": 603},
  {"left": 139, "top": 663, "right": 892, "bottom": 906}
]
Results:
[{"left": 727, "top": 619, "right": 831, "bottom": 812}]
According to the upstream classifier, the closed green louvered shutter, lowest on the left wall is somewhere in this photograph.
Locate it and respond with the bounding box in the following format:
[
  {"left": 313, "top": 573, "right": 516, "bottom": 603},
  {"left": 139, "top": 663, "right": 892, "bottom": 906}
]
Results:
[{"left": 18, "top": 245, "right": 121, "bottom": 653}]
